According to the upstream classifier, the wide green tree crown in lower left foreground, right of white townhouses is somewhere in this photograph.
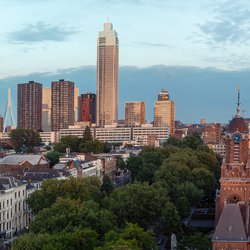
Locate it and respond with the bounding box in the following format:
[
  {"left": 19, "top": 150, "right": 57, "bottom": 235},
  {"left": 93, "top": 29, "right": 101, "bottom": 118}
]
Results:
[{"left": 30, "top": 197, "right": 115, "bottom": 236}]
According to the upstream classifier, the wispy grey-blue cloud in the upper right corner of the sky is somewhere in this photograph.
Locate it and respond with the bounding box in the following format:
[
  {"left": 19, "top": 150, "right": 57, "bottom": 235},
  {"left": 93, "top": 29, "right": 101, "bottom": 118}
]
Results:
[{"left": 199, "top": 1, "right": 250, "bottom": 44}]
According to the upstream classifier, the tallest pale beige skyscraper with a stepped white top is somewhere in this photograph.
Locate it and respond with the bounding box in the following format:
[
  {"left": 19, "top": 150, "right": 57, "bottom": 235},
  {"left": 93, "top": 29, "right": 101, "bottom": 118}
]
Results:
[{"left": 96, "top": 22, "right": 119, "bottom": 127}]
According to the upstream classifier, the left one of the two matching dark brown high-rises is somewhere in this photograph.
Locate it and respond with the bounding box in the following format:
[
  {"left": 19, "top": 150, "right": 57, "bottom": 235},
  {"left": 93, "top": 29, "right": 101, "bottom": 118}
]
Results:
[{"left": 17, "top": 81, "right": 42, "bottom": 130}]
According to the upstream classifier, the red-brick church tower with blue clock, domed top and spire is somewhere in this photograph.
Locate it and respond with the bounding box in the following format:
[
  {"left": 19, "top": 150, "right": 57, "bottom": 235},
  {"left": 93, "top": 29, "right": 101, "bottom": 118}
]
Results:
[{"left": 212, "top": 92, "right": 250, "bottom": 250}]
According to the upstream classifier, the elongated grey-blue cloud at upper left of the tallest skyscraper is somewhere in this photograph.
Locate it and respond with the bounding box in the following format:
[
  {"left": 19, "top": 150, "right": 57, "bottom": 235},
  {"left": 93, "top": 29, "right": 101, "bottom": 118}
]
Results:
[{"left": 8, "top": 22, "right": 77, "bottom": 44}]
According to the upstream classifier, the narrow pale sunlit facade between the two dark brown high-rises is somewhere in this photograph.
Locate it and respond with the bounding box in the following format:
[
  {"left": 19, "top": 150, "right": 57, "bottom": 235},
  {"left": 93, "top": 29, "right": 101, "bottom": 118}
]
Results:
[{"left": 42, "top": 88, "right": 51, "bottom": 132}]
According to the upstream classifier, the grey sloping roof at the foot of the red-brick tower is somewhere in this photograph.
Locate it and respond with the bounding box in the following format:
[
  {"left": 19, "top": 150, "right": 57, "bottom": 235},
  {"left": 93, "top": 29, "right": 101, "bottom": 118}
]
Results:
[{"left": 212, "top": 203, "right": 248, "bottom": 242}]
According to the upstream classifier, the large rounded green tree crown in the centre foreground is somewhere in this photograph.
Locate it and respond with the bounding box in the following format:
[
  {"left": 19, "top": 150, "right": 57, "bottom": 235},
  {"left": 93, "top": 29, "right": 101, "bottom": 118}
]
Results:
[{"left": 109, "top": 183, "right": 169, "bottom": 228}]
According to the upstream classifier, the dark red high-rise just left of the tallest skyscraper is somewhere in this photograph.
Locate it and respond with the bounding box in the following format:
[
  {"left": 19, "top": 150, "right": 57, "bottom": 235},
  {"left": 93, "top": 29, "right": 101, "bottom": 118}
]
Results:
[{"left": 79, "top": 93, "right": 96, "bottom": 123}]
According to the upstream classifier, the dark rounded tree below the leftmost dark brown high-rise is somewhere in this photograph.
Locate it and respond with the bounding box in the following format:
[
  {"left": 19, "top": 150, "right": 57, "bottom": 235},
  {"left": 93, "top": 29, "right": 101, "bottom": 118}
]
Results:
[{"left": 10, "top": 128, "right": 41, "bottom": 153}]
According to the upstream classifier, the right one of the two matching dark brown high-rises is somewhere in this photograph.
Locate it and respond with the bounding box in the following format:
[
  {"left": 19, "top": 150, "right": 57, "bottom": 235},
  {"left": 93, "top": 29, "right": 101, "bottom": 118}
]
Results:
[{"left": 51, "top": 79, "right": 75, "bottom": 131}]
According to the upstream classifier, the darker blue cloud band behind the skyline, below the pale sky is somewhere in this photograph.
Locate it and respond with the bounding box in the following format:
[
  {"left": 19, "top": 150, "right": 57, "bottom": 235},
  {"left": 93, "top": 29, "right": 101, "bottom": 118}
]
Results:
[{"left": 0, "top": 65, "right": 250, "bottom": 124}]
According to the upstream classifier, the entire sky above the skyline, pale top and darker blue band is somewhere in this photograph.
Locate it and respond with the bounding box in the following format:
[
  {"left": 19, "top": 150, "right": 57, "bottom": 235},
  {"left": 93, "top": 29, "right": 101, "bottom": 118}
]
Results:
[{"left": 0, "top": 0, "right": 250, "bottom": 122}]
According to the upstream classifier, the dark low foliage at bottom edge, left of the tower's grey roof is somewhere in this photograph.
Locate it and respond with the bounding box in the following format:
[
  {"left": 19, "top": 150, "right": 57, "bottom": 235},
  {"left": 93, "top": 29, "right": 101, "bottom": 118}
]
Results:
[{"left": 177, "top": 233, "right": 211, "bottom": 250}]
